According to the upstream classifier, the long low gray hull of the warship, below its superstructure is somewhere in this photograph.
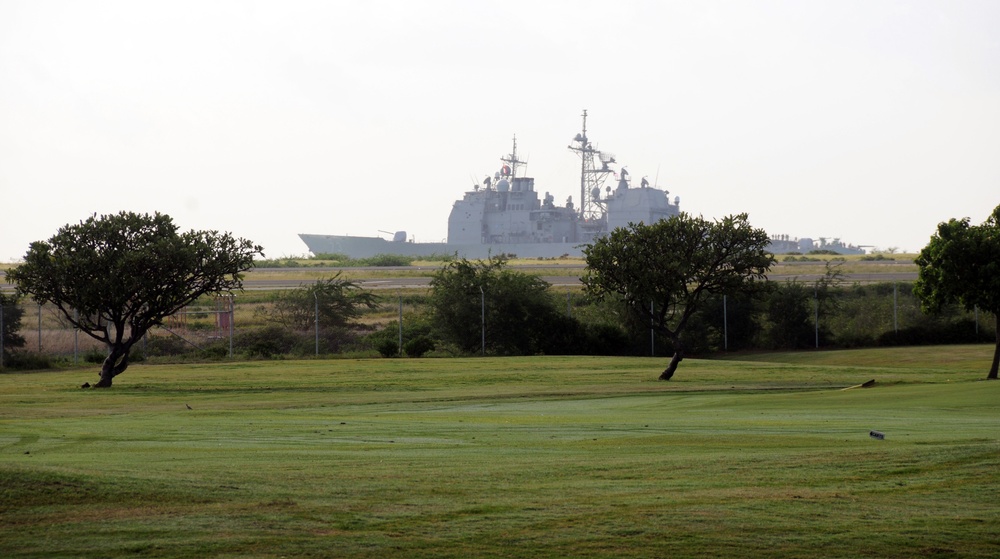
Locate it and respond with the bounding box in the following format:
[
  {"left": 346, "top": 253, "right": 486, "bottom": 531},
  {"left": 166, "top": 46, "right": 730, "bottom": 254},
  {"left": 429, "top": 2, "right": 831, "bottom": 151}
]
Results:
[{"left": 299, "top": 233, "right": 587, "bottom": 259}]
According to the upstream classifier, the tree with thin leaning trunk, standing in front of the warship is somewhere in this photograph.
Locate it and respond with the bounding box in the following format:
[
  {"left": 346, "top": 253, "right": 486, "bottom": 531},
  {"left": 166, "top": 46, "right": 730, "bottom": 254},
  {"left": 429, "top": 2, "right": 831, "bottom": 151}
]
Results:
[{"left": 582, "top": 213, "right": 774, "bottom": 380}]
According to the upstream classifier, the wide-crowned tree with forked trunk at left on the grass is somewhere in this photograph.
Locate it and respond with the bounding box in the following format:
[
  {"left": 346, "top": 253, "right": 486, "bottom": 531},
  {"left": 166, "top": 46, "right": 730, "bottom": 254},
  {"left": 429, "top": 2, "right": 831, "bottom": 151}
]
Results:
[{"left": 7, "top": 212, "right": 263, "bottom": 387}]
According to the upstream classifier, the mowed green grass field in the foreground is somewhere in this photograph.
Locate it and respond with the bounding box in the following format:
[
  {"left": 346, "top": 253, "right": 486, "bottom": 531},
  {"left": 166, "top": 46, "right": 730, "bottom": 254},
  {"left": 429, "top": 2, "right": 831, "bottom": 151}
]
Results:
[{"left": 0, "top": 346, "right": 1000, "bottom": 558}]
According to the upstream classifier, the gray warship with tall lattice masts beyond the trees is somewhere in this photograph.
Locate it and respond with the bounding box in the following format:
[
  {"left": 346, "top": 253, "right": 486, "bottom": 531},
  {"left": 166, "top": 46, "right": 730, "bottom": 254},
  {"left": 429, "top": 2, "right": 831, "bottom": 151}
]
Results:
[{"left": 299, "top": 111, "right": 680, "bottom": 259}]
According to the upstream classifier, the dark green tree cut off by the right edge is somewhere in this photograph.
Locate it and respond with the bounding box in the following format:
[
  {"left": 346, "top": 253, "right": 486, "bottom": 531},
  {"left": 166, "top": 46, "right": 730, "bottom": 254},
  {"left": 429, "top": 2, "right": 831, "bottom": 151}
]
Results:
[{"left": 913, "top": 206, "right": 1000, "bottom": 379}]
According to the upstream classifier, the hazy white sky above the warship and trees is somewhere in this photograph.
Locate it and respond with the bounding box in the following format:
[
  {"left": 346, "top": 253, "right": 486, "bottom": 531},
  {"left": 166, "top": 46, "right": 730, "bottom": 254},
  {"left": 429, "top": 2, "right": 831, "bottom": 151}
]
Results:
[{"left": 0, "top": 0, "right": 1000, "bottom": 261}]
